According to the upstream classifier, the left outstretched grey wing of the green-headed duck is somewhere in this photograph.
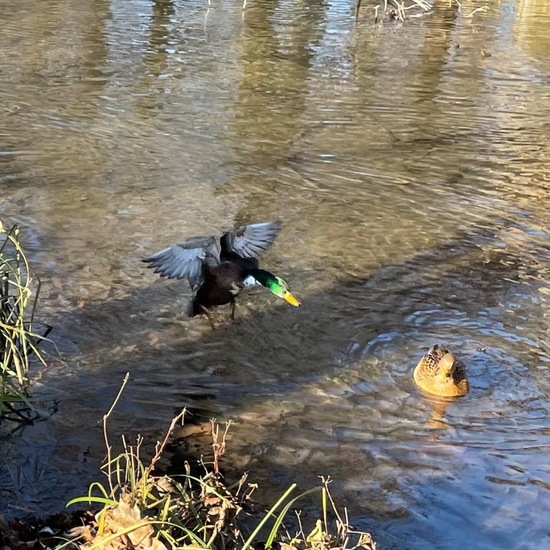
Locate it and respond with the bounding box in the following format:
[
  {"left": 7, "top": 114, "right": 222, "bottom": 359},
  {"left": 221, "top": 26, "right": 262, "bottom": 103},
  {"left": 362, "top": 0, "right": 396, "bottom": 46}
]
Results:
[{"left": 143, "top": 237, "right": 220, "bottom": 291}]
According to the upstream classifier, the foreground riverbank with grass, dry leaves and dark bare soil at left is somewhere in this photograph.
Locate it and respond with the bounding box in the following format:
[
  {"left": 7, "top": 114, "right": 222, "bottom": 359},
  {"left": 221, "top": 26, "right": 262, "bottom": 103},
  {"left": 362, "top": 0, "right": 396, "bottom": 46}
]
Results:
[{"left": 0, "top": 402, "right": 376, "bottom": 550}]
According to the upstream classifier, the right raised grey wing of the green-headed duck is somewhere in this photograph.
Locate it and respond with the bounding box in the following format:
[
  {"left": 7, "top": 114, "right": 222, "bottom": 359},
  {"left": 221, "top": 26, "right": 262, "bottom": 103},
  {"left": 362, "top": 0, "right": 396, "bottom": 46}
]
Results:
[{"left": 220, "top": 221, "right": 281, "bottom": 258}]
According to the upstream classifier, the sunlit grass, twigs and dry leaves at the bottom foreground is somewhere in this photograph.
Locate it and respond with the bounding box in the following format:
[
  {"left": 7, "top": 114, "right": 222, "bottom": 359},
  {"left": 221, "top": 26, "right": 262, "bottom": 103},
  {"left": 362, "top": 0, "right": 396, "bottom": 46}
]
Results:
[{"left": 60, "top": 375, "right": 376, "bottom": 550}]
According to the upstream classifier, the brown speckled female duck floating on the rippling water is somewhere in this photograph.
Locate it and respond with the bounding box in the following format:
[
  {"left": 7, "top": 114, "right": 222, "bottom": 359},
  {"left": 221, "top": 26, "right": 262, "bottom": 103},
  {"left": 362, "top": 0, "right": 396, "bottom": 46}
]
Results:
[{"left": 413, "top": 344, "right": 470, "bottom": 397}]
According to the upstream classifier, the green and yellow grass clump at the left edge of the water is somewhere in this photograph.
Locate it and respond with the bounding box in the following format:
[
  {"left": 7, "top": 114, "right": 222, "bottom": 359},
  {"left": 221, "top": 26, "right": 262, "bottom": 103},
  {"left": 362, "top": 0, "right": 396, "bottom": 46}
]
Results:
[{"left": 0, "top": 222, "right": 49, "bottom": 418}]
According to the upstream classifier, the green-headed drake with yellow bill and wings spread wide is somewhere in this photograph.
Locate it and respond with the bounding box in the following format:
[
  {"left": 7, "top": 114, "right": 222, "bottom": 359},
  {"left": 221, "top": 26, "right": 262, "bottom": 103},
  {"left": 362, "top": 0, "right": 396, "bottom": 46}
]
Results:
[{"left": 143, "top": 221, "right": 300, "bottom": 328}]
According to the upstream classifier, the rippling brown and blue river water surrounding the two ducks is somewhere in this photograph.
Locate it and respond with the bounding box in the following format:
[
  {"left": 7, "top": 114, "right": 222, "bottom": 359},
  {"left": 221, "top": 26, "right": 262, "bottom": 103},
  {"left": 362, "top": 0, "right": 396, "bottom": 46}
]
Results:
[{"left": 0, "top": 0, "right": 550, "bottom": 549}]
